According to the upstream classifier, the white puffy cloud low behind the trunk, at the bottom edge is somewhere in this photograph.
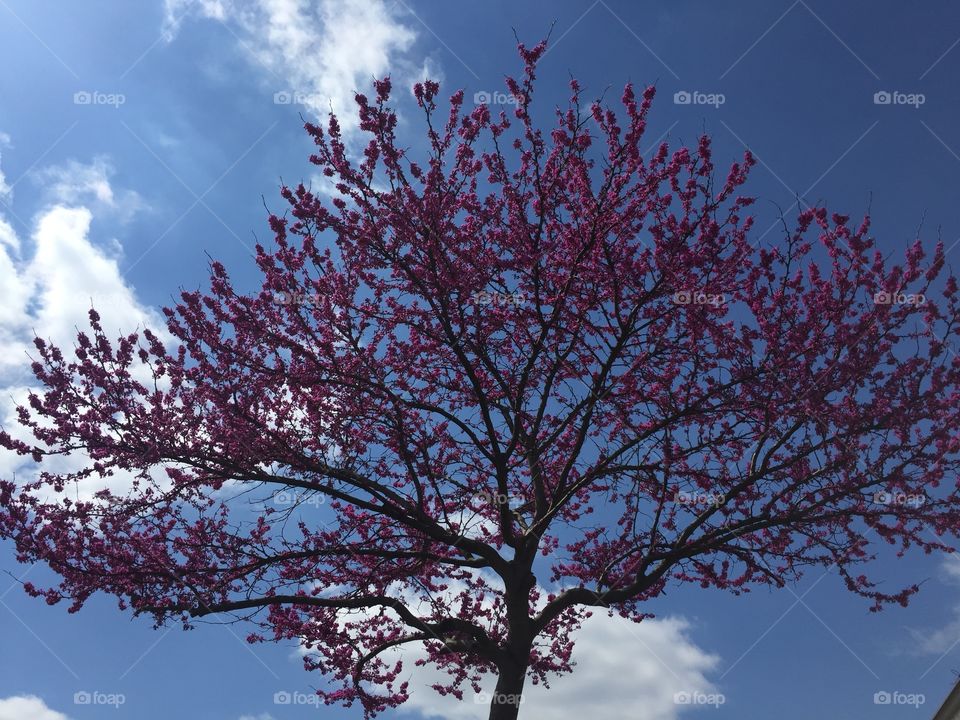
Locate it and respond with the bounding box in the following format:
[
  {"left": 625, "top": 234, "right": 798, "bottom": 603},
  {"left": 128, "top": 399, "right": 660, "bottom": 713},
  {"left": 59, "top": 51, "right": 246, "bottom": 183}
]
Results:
[{"left": 400, "top": 612, "right": 719, "bottom": 720}]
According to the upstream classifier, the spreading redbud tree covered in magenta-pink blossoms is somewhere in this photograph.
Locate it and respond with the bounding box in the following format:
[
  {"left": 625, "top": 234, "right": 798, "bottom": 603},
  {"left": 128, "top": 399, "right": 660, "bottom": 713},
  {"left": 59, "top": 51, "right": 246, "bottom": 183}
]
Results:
[{"left": 0, "top": 43, "right": 960, "bottom": 720}]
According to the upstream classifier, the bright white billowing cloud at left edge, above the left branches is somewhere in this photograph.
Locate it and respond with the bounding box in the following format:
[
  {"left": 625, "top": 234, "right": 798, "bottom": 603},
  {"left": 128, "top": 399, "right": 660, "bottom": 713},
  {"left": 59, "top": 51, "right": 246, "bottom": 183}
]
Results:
[{"left": 0, "top": 154, "right": 167, "bottom": 496}]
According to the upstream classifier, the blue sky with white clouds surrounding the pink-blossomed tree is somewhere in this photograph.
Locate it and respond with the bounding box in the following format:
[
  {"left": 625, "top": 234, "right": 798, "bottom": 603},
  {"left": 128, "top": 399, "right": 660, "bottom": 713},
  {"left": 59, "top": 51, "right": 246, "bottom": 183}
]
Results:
[{"left": 0, "top": 0, "right": 960, "bottom": 720}]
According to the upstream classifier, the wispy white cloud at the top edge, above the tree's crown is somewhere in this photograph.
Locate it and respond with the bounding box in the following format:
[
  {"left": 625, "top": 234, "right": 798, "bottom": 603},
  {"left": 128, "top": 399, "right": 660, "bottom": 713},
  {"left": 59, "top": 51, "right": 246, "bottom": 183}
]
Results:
[{"left": 164, "top": 0, "right": 423, "bottom": 137}]
